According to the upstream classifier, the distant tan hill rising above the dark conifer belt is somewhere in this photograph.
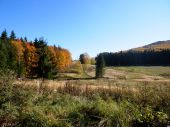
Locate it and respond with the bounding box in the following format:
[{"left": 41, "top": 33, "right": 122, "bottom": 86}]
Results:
[{"left": 131, "top": 40, "right": 170, "bottom": 51}]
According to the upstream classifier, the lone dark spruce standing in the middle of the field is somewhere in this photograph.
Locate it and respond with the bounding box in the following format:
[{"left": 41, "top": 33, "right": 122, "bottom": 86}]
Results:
[{"left": 96, "top": 54, "right": 105, "bottom": 78}]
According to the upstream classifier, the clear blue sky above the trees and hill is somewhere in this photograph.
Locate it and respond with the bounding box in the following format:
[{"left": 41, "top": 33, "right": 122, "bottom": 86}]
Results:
[{"left": 0, "top": 0, "right": 170, "bottom": 59}]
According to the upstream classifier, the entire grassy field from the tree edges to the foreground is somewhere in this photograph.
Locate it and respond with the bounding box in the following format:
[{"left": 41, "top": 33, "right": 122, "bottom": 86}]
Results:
[{"left": 0, "top": 65, "right": 170, "bottom": 127}]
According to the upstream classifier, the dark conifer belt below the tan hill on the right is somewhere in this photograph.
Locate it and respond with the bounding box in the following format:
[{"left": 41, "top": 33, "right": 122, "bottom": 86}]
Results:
[{"left": 101, "top": 49, "right": 170, "bottom": 66}]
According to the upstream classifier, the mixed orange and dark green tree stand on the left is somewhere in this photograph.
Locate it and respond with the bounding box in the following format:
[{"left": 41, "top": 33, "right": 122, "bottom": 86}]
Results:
[{"left": 0, "top": 30, "right": 72, "bottom": 78}]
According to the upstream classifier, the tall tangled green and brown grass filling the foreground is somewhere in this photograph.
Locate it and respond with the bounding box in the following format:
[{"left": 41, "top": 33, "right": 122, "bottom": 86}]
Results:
[{"left": 0, "top": 72, "right": 170, "bottom": 127}]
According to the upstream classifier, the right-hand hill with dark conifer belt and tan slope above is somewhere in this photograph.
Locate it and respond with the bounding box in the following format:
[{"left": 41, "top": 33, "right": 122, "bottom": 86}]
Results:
[{"left": 101, "top": 41, "right": 170, "bottom": 66}]
